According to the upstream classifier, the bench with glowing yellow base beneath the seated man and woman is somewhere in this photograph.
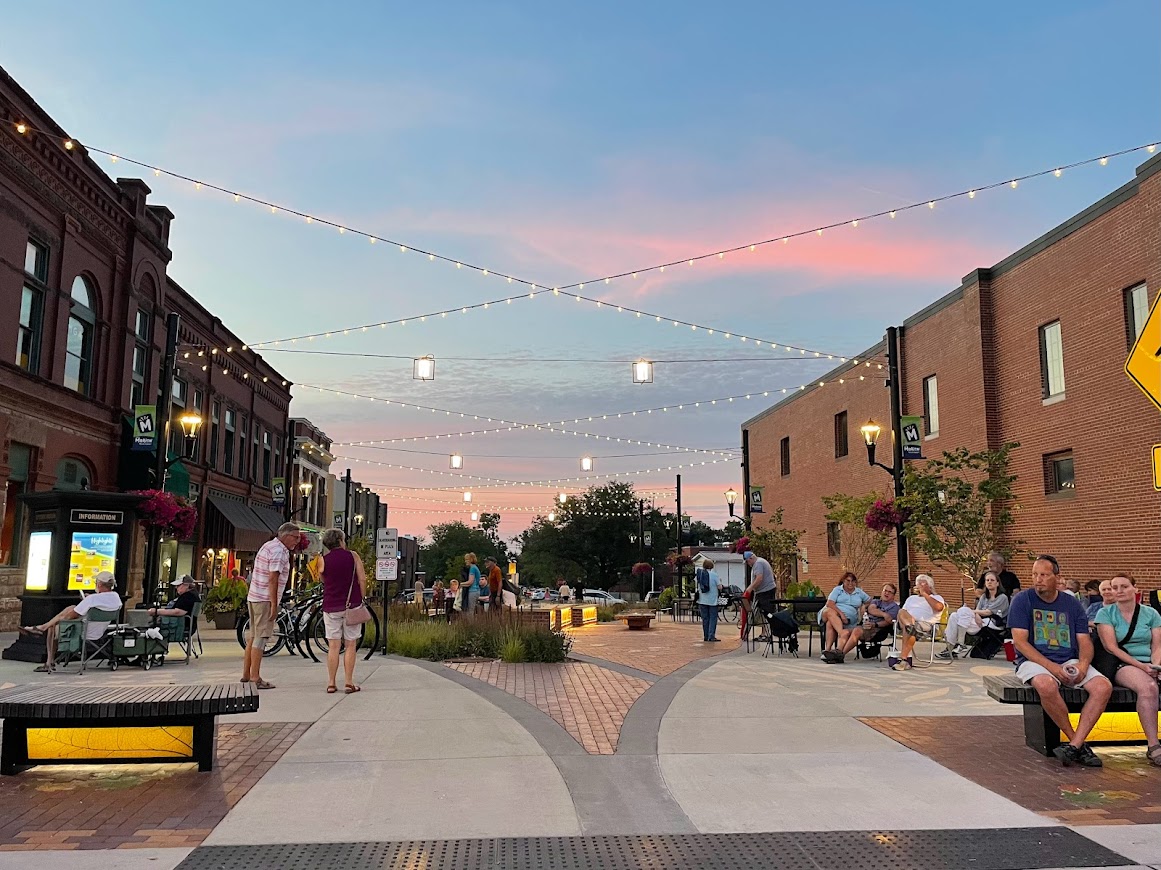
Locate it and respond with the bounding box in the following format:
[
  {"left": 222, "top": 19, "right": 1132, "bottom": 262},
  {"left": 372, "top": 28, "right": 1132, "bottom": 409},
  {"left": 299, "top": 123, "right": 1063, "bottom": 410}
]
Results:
[{"left": 983, "top": 674, "right": 1145, "bottom": 755}]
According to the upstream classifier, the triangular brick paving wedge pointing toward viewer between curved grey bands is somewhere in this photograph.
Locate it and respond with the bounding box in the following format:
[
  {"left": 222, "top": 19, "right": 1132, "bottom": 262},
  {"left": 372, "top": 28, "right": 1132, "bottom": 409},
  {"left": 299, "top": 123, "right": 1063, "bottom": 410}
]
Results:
[{"left": 447, "top": 662, "right": 650, "bottom": 755}]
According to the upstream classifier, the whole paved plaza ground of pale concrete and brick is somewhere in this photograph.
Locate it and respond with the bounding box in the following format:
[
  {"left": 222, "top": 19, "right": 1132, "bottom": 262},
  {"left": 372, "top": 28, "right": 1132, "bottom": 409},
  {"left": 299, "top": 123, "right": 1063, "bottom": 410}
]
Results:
[{"left": 0, "top": 624, "right": 1161, "bottom": 870}]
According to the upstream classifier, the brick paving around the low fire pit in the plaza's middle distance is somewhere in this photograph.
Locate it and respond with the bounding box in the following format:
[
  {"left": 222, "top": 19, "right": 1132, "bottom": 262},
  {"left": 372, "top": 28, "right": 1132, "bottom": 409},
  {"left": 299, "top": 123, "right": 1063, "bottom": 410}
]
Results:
[{"left": 569, "top": 617, "right": 741, "bottom": 676}]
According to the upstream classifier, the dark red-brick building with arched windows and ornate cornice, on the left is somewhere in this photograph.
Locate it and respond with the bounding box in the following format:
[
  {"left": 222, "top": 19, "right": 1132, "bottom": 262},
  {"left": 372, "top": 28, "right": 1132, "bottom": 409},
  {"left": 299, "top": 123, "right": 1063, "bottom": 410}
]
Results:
[{"left": 0, "top": 69, "right": 290, "bottom": 631}]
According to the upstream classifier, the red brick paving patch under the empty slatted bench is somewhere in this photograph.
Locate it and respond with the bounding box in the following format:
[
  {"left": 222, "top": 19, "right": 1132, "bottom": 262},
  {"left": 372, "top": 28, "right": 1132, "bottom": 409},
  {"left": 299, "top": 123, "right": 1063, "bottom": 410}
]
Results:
[{"left": 0, "top": 722, "right": 310, "bottom": 850}]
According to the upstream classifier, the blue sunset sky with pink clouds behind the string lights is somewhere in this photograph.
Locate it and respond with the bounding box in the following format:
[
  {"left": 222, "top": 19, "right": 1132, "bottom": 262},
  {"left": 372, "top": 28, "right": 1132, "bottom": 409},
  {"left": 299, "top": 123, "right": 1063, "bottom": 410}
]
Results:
[{"left": 0, "top": 0, "right": 1161, "bottom": 537}]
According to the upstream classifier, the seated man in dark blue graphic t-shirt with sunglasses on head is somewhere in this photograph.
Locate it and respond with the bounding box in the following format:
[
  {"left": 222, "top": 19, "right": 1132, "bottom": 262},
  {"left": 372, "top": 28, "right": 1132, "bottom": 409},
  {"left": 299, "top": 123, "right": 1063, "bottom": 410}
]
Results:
[{"left": 1008, "top": 555, "right": 1112, "bottom": 768}]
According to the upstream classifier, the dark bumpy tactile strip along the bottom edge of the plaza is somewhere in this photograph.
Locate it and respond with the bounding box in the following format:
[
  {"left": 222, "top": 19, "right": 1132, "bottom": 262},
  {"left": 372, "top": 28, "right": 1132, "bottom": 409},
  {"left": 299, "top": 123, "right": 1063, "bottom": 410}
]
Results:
[{"left": 178, "top": 827, "right": 1132, "bottom": 870}]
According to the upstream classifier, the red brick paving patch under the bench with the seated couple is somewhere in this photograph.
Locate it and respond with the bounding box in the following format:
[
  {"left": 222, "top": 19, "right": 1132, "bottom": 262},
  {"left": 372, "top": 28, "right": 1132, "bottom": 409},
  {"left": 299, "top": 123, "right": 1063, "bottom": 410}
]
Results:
[{"left": 860, "top": 716, "right": 1161, "bottom": 825}]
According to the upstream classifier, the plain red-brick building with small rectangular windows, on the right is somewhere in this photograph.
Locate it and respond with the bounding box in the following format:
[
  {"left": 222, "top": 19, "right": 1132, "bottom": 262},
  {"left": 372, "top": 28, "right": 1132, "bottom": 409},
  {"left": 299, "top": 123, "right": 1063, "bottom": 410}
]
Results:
[{"left": 742, "top": 156, "right": 1161, "bottom": 589}]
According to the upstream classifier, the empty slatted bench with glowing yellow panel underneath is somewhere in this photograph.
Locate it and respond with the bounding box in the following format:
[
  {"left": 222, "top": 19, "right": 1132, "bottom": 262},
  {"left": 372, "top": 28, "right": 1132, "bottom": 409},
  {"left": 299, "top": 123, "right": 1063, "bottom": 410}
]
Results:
[{"left": 0, "top": 683, "right": 258, "bottom": 776}]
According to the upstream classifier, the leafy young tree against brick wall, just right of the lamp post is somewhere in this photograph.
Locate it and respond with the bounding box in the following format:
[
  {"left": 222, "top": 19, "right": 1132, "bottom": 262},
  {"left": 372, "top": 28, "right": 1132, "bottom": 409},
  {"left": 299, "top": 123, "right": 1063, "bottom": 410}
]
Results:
[{"left": 900, "top": 443, "right": 1023, "bottom": 584}]
